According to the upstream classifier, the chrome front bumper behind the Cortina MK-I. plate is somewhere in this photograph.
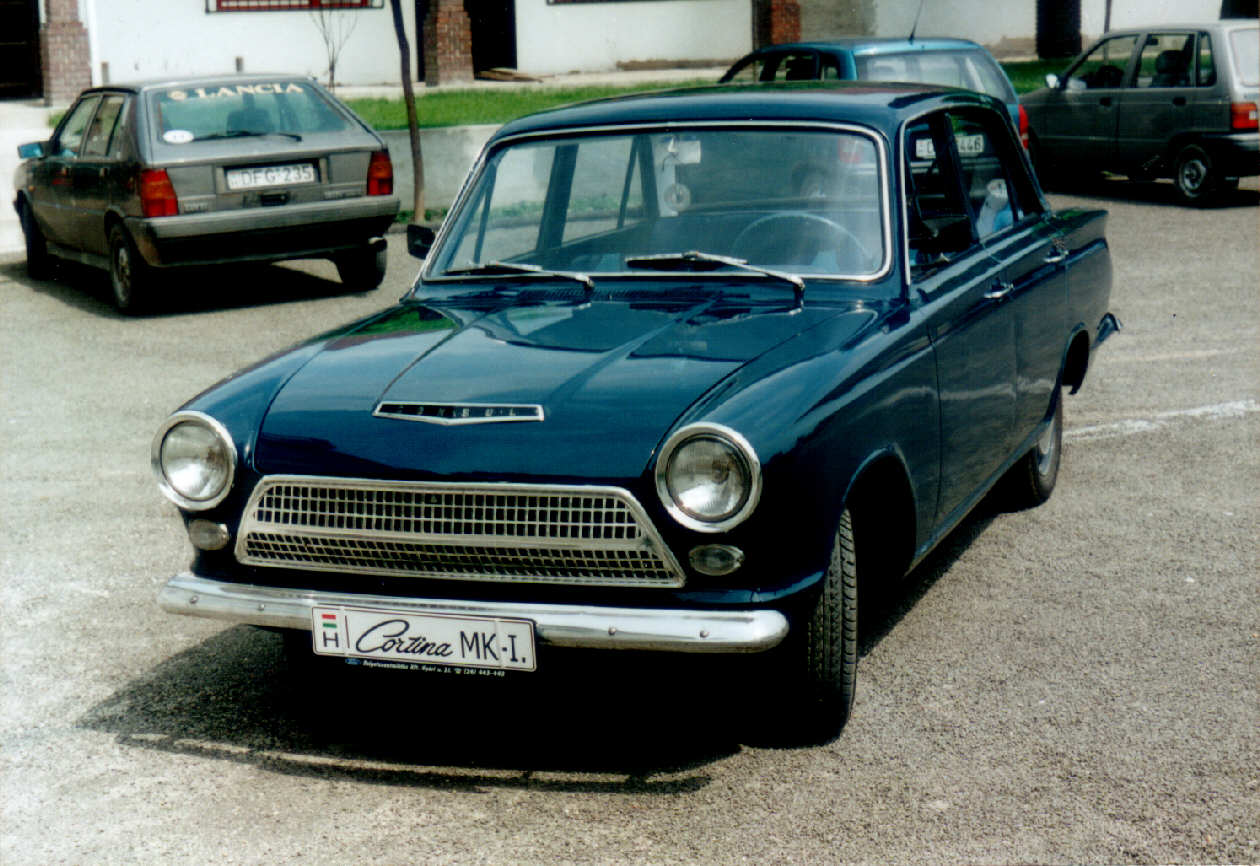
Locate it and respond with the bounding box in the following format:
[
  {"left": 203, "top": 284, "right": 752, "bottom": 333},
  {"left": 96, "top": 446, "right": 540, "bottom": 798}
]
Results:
[{"left": 158, "top": 572, "right": 788, "bottom": 653}]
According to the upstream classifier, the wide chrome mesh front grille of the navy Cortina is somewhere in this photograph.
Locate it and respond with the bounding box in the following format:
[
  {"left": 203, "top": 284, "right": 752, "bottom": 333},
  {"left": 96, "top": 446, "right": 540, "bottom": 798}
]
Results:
[{"left": 236, "top": 476, "right": 683, "bottom": 586}]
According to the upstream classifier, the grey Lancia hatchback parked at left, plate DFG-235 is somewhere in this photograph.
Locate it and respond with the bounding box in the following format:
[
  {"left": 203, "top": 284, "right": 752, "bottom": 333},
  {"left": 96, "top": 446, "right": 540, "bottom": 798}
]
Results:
[{"left": 14, "top": 76, "right": 398, "bottom": 311}]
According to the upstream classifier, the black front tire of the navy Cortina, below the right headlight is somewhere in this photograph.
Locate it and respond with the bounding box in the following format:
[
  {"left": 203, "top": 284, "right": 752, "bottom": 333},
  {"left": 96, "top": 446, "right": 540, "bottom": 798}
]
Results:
[{"left": 765, "top": 509, "right": 858, "bottom": 744}]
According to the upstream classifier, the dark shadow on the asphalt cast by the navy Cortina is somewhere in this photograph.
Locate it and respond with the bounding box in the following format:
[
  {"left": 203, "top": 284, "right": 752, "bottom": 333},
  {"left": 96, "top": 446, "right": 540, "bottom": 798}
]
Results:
[{"left": 78, "top": 500, "right": 999, "bottom": 781}]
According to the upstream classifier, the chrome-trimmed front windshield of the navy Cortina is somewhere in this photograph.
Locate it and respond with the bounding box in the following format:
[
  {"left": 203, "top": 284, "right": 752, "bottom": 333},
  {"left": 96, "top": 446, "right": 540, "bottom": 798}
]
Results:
[{"left": 426, "top": 127, "right": 887, "bottom": 277}]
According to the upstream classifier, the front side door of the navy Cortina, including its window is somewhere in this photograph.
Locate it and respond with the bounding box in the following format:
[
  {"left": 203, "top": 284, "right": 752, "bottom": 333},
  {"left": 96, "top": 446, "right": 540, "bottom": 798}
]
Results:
[{"left": 902, "top": 112, "right": 1016, "bottom": 522}]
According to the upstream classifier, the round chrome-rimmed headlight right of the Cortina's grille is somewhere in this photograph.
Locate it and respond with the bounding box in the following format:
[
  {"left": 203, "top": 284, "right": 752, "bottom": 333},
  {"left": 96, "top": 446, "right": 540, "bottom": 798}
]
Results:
[{"left": 656, "top": 425, "right": 761, "bottom": 532}]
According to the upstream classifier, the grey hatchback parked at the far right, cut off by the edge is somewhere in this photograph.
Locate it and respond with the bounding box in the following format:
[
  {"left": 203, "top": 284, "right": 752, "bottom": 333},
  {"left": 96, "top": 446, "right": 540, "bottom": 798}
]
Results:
[{"left": 1023, "top": 18, "right": 1260, "bottom": 204}]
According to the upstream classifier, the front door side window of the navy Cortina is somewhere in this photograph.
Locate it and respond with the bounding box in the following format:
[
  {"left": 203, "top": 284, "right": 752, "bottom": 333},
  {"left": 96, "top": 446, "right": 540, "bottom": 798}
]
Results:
[{"left": 902, "top": 115, "right": 975, "bottom": 276}]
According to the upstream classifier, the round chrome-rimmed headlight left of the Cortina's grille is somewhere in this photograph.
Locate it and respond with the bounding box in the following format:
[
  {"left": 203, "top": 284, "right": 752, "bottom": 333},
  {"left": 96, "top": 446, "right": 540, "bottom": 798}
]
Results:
[{"left": 152, "top": 412, "right": 236, "bottom": 511}]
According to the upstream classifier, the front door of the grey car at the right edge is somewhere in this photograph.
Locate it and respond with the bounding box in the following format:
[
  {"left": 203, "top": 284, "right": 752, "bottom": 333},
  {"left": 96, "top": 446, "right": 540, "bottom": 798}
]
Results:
[{"left": 1036, "top": 34, "right": 1138, "bottom": 169}]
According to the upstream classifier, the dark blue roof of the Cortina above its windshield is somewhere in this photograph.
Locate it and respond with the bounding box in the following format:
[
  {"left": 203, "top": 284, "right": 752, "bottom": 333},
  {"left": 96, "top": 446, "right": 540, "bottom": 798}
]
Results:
[{"left": 491, "top": 81, "right": 1005, "bottom": 141}]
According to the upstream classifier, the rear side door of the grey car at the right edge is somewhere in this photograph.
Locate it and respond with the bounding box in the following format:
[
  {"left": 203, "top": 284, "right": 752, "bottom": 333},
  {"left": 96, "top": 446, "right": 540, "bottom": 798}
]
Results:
[{"left": 1116, "top": 30, "right": 1197, "bottom": 170}]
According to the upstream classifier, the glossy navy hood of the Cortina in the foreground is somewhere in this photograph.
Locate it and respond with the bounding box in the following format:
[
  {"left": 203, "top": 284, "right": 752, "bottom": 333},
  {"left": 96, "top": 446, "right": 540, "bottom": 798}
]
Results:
[{"left": 253, "top": 289, "right": 872, "bottom": 483}]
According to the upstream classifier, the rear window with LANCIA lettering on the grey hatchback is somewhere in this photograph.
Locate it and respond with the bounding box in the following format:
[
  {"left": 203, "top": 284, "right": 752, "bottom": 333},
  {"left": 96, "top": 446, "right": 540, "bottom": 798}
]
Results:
[{"left": 149, "top": 79, "right": 349, "bottom": 144}]
